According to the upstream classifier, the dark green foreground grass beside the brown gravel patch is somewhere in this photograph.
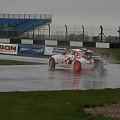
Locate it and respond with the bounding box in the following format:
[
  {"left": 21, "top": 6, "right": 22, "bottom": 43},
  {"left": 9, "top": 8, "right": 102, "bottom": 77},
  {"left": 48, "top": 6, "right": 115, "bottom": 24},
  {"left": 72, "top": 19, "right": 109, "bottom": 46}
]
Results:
[{"left": 0, "top": 89, "right": 120, "bottom": 120}]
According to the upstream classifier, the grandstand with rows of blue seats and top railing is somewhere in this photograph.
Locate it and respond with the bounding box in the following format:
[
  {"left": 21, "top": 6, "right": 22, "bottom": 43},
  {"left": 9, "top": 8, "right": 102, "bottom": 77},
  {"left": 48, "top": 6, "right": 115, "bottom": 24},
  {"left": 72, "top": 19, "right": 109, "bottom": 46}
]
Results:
[{"left": 0, "top": 14, "right": 52, "bottom": 38}]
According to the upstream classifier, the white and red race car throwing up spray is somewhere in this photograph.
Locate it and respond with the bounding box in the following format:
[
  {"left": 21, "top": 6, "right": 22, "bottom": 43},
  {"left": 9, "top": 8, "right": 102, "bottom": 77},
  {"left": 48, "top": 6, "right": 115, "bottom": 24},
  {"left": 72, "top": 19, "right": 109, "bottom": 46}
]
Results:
[{"left": 49, "top": 49, "right": 107, "bottom": 72}]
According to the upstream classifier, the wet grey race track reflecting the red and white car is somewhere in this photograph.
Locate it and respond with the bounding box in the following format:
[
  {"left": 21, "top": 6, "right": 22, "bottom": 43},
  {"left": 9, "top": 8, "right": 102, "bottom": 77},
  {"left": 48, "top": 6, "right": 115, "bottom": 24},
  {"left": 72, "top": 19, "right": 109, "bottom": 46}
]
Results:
[{"left": 0, "top": 56, "right": 120, "bottom": 91}]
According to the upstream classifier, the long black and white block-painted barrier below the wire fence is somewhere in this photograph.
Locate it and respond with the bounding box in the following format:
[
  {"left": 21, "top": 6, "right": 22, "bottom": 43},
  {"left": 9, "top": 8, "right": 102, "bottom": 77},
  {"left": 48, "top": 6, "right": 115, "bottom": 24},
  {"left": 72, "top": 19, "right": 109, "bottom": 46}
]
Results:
[{"left": 0, "top": 38, "right": 120, "bottom": 48}]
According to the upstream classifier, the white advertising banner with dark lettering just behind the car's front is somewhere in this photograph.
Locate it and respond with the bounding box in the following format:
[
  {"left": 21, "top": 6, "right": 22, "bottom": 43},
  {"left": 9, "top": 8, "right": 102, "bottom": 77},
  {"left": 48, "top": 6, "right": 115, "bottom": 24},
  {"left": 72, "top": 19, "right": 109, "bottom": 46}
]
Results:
[{"left": 44, "top": 47, "right": 66, "bottom": 55}]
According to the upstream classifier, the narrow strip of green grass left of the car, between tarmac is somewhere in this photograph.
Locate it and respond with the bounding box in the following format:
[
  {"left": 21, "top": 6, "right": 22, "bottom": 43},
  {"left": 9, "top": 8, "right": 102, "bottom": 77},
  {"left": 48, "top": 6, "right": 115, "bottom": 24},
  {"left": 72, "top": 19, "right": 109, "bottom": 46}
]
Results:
[{"left": 0, "top": 60, "right": 45, "bottom": 65}]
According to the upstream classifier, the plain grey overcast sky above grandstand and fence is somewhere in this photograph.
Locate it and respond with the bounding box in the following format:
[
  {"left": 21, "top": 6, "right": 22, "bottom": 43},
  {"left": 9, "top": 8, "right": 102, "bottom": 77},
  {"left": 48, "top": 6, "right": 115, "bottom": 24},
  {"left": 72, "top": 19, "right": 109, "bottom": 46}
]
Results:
[{"left": 0, "top": 0, "right": 120, "bottom": 27}]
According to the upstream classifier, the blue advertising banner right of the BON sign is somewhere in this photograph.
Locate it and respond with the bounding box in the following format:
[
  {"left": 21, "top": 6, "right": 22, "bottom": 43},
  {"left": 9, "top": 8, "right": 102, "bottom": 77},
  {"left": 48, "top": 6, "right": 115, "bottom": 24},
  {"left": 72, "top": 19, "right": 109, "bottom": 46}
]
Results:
[{"left": 18, "top": 45, "right": 45, "bottom": 55}]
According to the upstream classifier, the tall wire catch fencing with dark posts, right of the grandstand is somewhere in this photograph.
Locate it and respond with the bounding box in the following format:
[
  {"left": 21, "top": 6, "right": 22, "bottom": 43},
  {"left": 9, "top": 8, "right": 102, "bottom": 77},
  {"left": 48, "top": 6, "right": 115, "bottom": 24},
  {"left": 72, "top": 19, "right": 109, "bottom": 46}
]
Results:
[{"left": 17, "top": 25, "right": 120, "bottom": 43}]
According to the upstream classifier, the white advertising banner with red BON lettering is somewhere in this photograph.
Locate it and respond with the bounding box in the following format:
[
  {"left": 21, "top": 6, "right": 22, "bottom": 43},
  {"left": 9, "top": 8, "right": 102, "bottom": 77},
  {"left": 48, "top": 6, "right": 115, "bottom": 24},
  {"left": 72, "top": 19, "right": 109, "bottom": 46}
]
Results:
[{"left": 0, "top": 44, "right": 18, "bottom": 54}]
